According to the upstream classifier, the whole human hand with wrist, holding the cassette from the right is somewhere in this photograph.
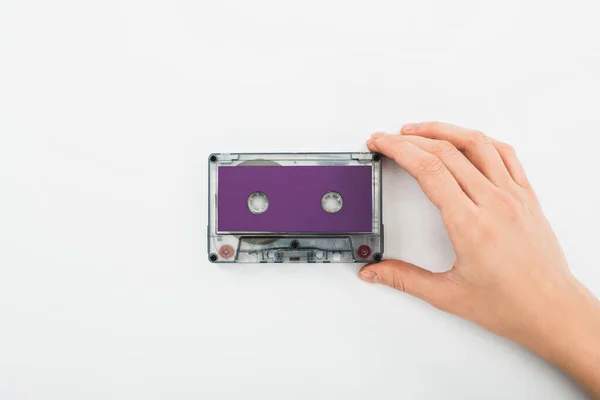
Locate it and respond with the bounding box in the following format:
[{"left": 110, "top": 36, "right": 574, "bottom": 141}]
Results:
[{"left": 359, "top": 122, "right": 600, "bottom": 395}]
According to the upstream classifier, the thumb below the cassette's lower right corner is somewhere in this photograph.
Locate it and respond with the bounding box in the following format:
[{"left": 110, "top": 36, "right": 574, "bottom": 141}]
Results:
[{"left": 358, "top": 260, "right": 445, "bottom": 305}]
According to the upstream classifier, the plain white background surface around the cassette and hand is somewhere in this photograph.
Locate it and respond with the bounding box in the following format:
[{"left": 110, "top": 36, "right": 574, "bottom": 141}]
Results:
[{"left": 0, "top": 0, "right": 600, "bottom": 400}]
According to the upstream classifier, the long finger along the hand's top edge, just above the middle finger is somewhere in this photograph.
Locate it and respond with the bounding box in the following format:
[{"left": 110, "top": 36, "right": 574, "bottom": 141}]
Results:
[{"left": 401, "top": 122, "right": 514, "bottom": 189}]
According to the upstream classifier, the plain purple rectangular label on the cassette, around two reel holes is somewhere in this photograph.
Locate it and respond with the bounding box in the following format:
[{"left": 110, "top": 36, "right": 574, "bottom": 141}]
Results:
[{"left": 217, "top": 165, "right": 373, "bottom": 233}]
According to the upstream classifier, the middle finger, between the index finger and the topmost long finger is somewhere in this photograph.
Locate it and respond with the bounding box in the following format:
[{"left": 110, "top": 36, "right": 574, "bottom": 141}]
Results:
[{"left": 396, "top": 135, "right": 494, "bottom": 204}]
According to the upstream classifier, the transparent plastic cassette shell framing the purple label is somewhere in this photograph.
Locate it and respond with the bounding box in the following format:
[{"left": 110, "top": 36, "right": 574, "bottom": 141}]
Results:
[{"left": 208, "top": 152, "right": 384, "bottom": 263}]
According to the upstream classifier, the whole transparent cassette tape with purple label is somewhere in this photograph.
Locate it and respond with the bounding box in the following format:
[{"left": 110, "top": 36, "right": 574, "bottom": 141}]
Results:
[{"left": 208, "top": 153, "right": 383, "bottom": 263}]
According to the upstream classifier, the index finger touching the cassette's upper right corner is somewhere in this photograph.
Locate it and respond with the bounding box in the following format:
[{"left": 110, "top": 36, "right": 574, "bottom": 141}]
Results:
[{"left": 367, "top": 135, "right": 475, "bottom": 215}]
